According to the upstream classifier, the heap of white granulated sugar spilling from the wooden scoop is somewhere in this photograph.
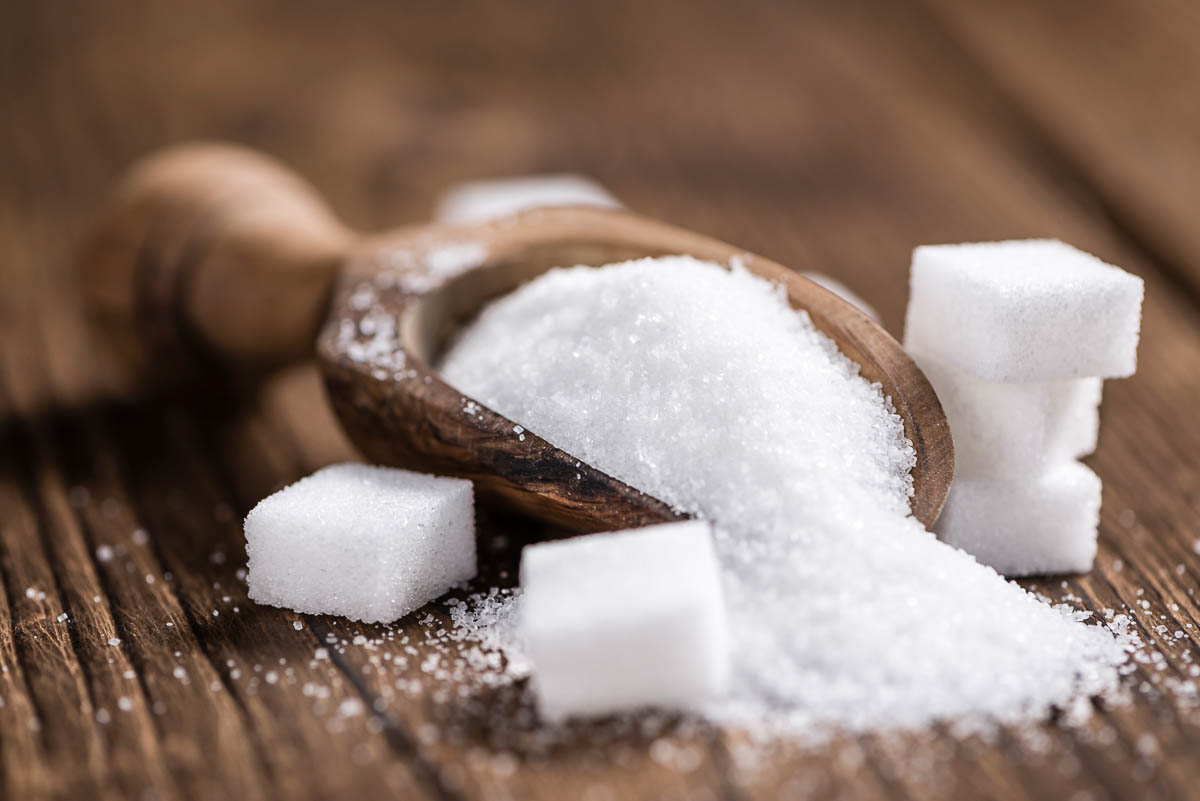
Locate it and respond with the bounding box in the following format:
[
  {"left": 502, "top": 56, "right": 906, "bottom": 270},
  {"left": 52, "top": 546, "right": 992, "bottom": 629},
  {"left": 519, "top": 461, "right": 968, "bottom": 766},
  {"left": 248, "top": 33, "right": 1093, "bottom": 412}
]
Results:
[{"left": 443, "top": 258, "right": 1127, "bottom": 735}]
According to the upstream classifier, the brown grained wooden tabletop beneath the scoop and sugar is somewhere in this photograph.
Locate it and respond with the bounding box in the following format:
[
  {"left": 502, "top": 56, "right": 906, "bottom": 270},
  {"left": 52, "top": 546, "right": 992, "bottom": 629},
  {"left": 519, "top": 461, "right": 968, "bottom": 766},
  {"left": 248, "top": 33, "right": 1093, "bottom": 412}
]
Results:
[{"left": 0, "top": 0, "right": 1200, "bottom": 801}]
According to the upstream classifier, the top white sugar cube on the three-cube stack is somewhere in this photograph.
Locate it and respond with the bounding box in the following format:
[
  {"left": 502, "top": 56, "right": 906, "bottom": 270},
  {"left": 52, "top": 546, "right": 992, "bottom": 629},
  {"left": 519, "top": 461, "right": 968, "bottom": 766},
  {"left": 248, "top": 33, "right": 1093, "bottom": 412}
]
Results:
[{"left": 905, "top": 240, "right": 1144, "bottom": 381}]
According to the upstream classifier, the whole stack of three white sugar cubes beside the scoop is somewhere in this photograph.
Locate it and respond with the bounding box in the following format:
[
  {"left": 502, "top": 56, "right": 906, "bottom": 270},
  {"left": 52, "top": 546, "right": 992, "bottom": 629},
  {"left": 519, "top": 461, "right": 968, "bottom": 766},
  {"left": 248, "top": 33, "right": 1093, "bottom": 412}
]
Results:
[{"left": 905, "top": 240, "right": 1144, "bottom": 576}]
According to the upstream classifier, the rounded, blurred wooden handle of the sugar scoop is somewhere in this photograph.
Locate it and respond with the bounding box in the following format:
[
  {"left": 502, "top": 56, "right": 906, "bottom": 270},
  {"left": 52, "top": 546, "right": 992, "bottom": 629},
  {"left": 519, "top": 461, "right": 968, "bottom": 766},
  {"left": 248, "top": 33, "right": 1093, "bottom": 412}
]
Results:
[{"left": 80, "top": 144, "right": 355, "bottom": 384}]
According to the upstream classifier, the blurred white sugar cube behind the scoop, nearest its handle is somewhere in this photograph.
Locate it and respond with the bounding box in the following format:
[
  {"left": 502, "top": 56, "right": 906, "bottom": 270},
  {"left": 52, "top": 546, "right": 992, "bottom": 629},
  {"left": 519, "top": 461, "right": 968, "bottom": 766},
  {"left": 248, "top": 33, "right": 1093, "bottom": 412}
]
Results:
[{"left": 434, "top": 174, "right": 620, "bottom": 223}]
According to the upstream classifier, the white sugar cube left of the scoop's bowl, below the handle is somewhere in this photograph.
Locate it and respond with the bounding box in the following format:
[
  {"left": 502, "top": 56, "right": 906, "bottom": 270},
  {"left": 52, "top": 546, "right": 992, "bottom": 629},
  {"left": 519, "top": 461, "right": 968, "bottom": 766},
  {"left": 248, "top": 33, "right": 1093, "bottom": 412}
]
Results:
[{"left": 245, "top": 464, "right": 475, "bottom": 622}]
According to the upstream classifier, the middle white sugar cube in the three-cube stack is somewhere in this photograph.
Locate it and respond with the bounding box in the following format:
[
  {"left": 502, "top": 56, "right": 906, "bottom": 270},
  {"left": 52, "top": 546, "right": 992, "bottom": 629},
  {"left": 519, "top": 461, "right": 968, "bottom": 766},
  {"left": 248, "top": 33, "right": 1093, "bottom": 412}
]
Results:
[{"left": 910, "top": 351, "right": 1100, "bottom": 477}]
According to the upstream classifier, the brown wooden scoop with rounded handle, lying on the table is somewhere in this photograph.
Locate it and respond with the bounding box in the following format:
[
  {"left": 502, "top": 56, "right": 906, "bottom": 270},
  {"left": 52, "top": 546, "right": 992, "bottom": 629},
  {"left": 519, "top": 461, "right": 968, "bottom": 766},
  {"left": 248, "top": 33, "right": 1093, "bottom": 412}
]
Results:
[{"left": 84, "top": 145, "right": 954, "bottom": 531}]
